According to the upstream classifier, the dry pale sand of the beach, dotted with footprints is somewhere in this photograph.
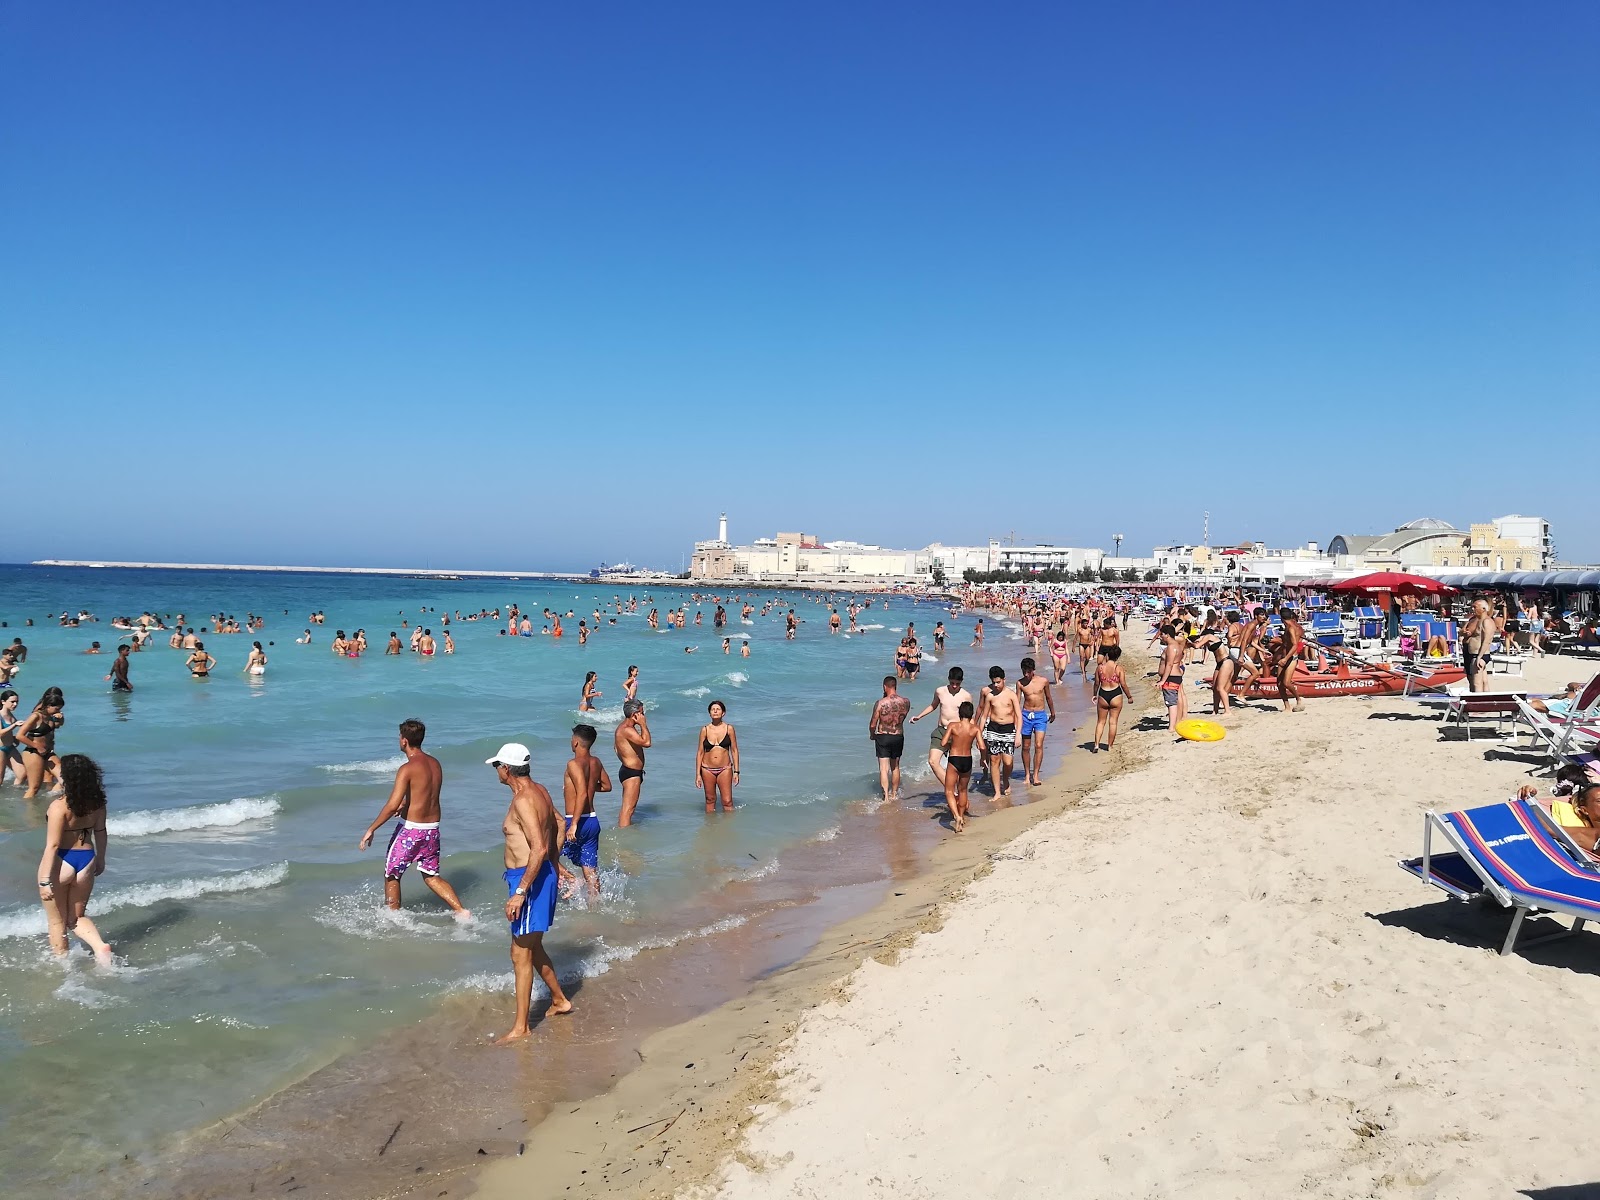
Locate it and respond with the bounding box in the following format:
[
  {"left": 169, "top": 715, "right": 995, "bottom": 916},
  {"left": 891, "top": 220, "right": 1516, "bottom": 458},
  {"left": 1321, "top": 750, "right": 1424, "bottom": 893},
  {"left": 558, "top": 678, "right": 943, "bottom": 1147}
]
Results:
[{"left": 693, "top": 659, "right": 1600, "bottom": 1200}]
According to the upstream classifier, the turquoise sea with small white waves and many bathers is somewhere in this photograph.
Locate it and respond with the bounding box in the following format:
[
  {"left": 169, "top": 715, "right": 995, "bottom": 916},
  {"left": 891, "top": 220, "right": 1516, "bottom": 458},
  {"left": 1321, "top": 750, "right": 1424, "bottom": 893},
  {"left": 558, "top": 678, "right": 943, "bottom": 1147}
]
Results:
[{"left": 0, "top": 566, "right": 1075, "bottom": 1195}]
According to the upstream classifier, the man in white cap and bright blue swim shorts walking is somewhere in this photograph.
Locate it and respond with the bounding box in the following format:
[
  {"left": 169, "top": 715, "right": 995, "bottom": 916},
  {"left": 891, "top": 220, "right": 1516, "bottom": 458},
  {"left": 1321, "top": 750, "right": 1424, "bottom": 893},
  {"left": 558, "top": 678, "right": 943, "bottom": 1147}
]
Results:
[{"left": 486, "top": 742, "right": 573, "bottom": 1043}]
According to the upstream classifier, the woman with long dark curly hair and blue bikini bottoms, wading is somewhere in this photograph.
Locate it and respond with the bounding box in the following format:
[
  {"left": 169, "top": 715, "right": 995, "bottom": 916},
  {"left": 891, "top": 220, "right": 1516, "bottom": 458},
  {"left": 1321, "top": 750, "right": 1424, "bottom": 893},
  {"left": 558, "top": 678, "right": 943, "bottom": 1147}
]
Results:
[{"left": 37, "top": 754, "right": 110, "bottom": 965}]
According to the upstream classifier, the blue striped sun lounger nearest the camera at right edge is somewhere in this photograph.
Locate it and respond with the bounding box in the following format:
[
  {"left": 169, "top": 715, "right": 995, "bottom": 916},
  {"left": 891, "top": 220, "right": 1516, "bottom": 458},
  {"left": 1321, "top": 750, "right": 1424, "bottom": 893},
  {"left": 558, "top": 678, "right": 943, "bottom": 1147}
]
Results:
[{"left": 1398, "top": 800, "right": 1600, "bottom": 955}]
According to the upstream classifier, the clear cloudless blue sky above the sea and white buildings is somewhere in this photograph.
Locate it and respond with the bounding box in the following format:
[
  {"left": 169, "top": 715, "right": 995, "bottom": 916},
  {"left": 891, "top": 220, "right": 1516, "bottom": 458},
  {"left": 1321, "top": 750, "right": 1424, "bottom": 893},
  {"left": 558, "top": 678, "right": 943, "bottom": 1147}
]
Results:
[{"left": 0, "top": 0, "right": 1600, "bottom": 568}]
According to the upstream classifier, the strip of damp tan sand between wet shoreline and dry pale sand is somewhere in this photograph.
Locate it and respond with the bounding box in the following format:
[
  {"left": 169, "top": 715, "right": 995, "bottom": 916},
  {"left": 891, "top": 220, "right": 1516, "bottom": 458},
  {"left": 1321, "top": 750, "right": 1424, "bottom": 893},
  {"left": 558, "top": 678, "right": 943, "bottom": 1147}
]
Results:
[{"left": 467, "top": 659, "right": 1150, "bottom": 1200}]
